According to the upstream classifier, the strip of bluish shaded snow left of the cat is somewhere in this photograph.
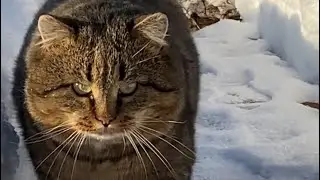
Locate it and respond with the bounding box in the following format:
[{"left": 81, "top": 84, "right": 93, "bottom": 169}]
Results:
[{"left": 1, "top": 0, "right": 43, "bottom": 180}]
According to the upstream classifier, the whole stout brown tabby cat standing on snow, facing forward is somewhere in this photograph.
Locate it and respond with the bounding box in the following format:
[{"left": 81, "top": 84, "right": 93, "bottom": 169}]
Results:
[{"left": 12, "top": 0, "right": 199, "bottom": 180}]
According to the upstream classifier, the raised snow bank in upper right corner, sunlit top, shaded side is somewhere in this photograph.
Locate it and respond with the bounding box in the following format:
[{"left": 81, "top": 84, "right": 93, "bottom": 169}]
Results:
[{"left": 236, "top": 0, "right": 319, "bottom": 84}]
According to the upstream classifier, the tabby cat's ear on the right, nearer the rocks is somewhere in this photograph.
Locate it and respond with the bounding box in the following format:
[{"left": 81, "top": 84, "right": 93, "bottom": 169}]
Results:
[{"left": 133, "top": 12, "right": 169, "bottom": 46}]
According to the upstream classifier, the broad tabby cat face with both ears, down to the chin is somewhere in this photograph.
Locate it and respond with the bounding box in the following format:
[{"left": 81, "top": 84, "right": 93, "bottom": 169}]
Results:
[{"left": 25, "top": 13, "right": 184, "bottom": 148}]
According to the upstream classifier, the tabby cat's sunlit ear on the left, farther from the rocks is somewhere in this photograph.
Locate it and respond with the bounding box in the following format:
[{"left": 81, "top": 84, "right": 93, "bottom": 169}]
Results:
[{"left": 38, "top": 14, "right": 74, "bottom": 46}]
